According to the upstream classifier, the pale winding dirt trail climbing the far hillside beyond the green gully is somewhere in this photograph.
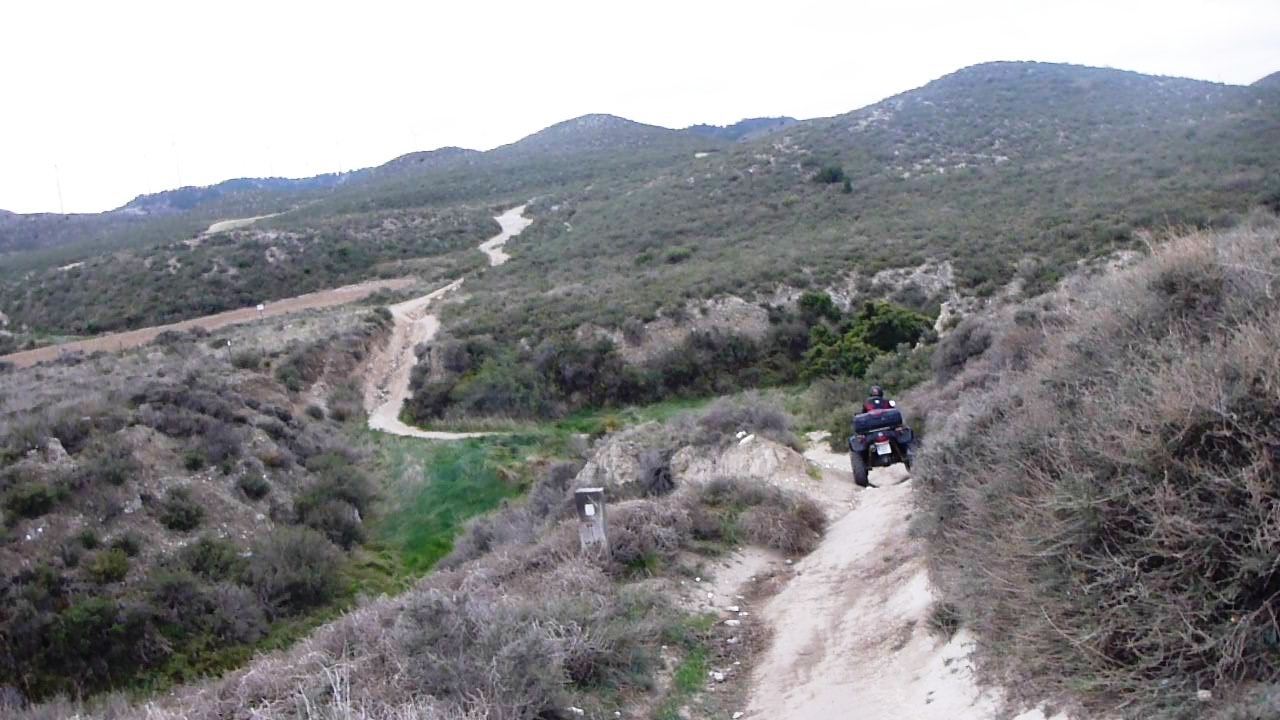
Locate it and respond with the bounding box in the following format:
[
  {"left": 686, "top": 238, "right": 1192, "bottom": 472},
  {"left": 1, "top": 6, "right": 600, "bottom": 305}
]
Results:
[{"left": 365, "top": 205, "right": 532, "bottom": 439}]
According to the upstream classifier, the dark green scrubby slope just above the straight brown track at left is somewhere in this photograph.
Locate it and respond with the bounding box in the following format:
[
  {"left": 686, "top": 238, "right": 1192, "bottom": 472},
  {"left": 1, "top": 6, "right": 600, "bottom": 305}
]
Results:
[{"left": 0, "top": 208, "right": 497, "bottom": 334}]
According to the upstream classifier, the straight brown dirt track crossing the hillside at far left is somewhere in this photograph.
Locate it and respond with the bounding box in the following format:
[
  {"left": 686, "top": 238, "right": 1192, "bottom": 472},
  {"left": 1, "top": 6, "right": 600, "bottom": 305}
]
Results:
[{"left": 0, "top": 272, "right": 415, "bottom": 368}]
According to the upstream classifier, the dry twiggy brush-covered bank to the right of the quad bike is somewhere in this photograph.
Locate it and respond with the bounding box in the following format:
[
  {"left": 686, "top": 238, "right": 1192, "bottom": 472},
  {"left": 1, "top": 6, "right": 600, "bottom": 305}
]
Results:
[{"left": 916, "top": 215, "right": 1280, "bottom": 719}]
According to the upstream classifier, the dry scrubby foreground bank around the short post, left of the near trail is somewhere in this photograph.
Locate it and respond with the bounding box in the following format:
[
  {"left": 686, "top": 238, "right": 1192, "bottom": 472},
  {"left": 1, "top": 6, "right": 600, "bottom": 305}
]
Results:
[{"left": 0, "top": 392, "right": 827, "bottom": 720}]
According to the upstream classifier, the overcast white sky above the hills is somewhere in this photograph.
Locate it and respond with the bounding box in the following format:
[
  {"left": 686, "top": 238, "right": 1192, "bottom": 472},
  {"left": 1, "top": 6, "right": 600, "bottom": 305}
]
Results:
[{"left": 0, "top": 0, "right": 1280, "bottom": 213}]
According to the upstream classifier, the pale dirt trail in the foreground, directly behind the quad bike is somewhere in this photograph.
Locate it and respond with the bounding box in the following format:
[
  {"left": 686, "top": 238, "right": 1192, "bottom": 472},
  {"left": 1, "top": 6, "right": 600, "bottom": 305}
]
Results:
[{"left": 746, "top": 437, "right": 1044, "bottom": 720}]
